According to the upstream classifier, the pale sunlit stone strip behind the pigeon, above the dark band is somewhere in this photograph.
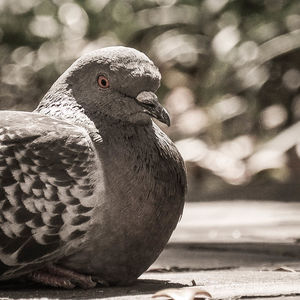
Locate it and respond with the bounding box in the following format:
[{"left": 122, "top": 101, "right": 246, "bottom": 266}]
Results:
[{"left": 171, "top": 200, "right": 300, "bottom": 243}]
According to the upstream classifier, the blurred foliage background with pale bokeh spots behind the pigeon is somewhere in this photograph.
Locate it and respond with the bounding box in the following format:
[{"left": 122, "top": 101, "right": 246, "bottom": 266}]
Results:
[{"left": 0, "top": 0, "right": 300, "bottom": 201}]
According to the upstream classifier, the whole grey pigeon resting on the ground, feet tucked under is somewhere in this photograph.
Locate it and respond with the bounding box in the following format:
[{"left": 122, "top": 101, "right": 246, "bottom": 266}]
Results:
[{"left": 0, "top": 46, "right": 186, "bottom": 288}]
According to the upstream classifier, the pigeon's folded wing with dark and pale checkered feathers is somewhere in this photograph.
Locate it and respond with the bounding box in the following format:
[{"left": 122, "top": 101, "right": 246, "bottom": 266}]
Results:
[{"left": 0, "top": 111, "right": 101, "bottom": 279}]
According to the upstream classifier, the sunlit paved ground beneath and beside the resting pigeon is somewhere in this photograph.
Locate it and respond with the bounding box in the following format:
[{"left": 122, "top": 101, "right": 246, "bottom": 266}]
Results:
[{"left": 0, "top": 200, "right": 300, "bottom": 300}]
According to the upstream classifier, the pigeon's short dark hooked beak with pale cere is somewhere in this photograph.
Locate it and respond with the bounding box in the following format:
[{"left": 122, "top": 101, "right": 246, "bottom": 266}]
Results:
[{"left": 135, "top": 91, "right": 171, "bottom": 126}]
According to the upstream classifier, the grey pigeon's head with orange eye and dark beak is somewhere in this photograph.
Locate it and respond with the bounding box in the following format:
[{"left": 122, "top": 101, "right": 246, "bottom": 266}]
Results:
[{"left": 58, "top": 47, "right": 170, "bottom": 126}]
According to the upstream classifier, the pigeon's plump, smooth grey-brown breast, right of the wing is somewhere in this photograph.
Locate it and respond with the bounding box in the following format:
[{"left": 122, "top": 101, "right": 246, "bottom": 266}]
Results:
[{"left": 62, "top": 123, "right": 185, "bottom": 283}]
